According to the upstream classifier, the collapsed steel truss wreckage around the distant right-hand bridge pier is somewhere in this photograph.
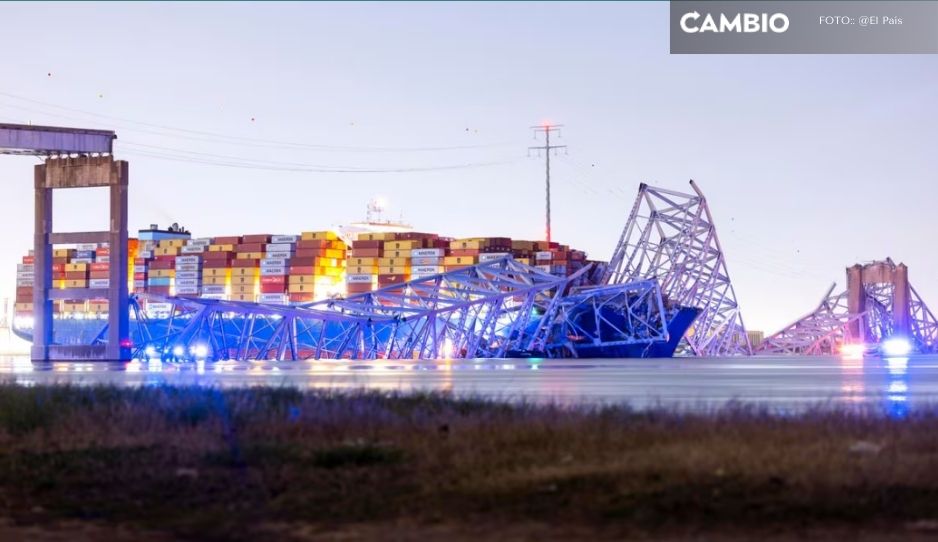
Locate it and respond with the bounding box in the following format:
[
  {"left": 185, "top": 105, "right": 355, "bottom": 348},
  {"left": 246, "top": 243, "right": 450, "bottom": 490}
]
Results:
[{"left": 757, "top": 278, "right": 938, "bottom": 356}]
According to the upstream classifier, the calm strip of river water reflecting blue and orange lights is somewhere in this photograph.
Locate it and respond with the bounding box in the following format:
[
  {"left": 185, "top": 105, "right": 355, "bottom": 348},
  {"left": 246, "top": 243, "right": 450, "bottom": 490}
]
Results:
[{"left": 0, "top": 356, "right": 938, "bottom": 417}]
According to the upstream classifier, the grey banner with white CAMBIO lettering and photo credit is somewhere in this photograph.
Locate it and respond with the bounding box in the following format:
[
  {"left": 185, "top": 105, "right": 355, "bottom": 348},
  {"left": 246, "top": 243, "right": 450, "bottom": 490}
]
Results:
[{"left": 671, "top": 0, "right": 938, "bottom": 54}]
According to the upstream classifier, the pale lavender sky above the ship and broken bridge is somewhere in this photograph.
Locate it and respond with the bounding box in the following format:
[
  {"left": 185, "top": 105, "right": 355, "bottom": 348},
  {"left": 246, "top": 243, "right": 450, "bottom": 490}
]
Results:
[{"left": 0, "top": 2, "right": 938, "bottom": 332}]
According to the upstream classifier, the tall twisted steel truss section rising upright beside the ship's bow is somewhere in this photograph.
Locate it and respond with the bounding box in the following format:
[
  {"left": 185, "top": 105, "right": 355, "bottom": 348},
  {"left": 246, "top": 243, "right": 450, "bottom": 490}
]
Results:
[{"left": 602, "top": 181, "right": 752, "bottom": 356}]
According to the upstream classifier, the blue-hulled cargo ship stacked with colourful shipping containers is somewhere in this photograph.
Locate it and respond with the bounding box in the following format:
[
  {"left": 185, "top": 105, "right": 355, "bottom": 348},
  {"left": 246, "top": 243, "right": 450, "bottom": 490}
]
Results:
[{"left": 12, "top": 216, "right": 696, "bottom": 357}]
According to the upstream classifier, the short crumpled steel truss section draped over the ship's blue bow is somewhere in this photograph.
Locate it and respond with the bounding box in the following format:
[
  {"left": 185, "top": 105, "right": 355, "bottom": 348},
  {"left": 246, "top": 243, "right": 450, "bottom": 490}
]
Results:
[{"left": 547, "top": 280, "right": 669, "bottom": 357}]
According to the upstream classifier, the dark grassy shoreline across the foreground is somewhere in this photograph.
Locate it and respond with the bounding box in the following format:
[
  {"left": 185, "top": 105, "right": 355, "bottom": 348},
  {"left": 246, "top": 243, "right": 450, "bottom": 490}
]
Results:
[{"left": 0, "top": 384, "right": 938, "bottom": 542}]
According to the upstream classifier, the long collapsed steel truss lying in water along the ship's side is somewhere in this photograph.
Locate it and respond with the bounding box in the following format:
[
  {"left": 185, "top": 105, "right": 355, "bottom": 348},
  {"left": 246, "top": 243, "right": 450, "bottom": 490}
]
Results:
[{"left": 122, "top": 258, "right": 576, "bottom": 360}]
